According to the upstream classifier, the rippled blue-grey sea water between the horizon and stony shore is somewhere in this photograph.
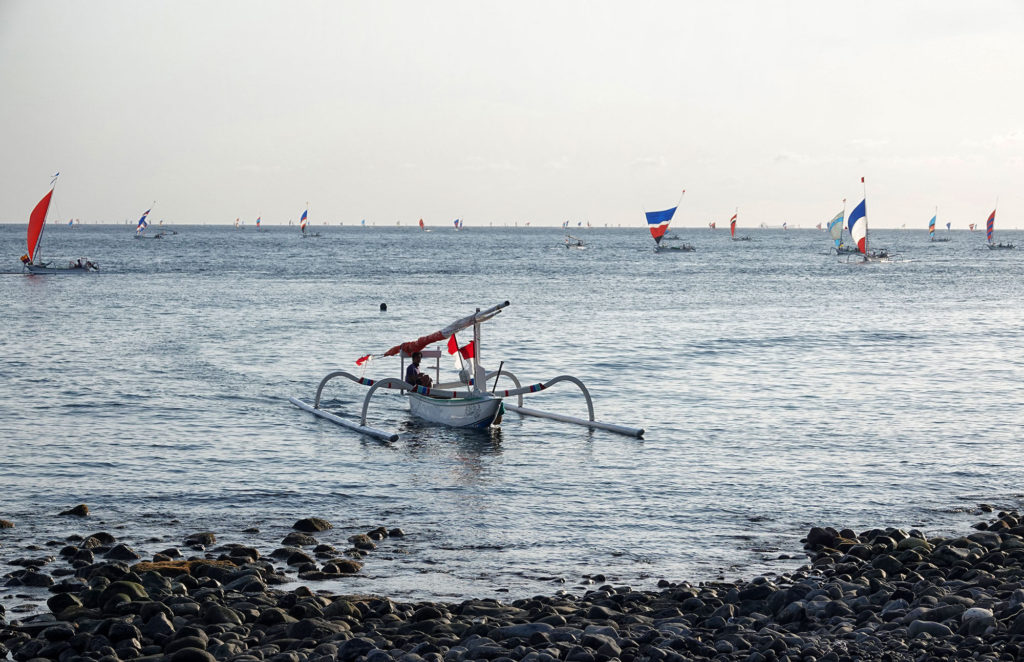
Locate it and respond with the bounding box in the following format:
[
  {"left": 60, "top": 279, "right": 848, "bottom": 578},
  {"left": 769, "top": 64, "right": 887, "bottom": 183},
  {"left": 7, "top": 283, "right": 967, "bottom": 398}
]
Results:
[{"left": 0, "top": 225, "right": 1024, "bottom": 599}]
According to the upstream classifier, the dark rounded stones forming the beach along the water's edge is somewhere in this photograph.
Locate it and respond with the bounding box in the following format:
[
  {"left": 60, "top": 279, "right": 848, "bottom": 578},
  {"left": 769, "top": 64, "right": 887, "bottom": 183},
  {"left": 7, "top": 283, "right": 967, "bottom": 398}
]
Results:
[{"left": 0, "top": 511, "right": 1024, "bottom": 662}]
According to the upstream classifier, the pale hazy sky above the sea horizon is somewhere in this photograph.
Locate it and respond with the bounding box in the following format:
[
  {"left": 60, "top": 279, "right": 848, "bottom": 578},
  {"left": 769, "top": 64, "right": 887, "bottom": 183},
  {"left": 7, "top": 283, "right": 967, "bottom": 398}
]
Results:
[{"left": 0, "top": 0, "right": 1024, "bottom": 229}]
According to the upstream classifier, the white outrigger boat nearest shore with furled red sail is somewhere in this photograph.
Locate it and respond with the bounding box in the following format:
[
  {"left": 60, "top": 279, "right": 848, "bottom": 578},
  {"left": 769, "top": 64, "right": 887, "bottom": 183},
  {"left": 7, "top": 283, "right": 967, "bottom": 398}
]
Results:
[{"left": 289, "top": 301, "right": 644, "bottom": 442}]
